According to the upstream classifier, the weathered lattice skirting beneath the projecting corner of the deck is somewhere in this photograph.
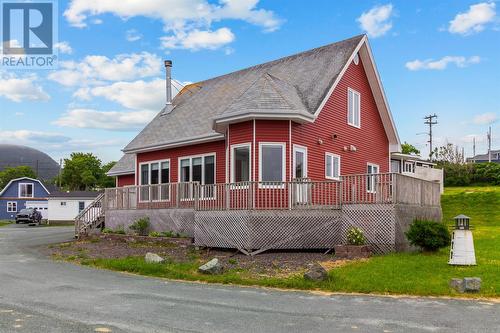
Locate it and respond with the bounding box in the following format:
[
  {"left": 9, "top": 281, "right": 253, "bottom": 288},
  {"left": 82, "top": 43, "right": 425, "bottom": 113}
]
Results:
[{"left": 194, "top": 204, "right": 441, "bottom": 254}]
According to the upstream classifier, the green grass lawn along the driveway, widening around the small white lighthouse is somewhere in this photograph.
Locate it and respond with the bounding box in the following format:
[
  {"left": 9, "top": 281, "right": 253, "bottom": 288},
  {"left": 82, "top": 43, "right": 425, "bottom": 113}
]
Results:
[{"left": 86, "top": 187, "right": 500, "bottom": 297}]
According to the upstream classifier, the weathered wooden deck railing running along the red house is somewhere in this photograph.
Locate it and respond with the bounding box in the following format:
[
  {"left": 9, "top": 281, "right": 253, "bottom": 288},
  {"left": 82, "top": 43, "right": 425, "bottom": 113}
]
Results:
[{"left": 104, "top": 173, "right": 440, "bottom": 210}]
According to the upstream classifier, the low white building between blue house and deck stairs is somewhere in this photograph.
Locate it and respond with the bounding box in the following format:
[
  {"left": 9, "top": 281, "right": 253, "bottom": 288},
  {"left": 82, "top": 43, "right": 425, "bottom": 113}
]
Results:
[{"left": 48, "top": 191, "right": 99, "bottom": 223}]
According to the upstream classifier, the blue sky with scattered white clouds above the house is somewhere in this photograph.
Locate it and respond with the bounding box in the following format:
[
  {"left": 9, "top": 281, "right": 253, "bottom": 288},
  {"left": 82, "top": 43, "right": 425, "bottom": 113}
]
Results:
[{"left": 0, "top": 0, "right": 500, "bottom": 161}]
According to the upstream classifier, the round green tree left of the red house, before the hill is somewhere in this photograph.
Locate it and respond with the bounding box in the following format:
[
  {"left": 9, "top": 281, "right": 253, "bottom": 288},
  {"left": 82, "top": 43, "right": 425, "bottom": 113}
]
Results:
[{"left": 61, "top": 153, "right": 103, "bottom": 191}]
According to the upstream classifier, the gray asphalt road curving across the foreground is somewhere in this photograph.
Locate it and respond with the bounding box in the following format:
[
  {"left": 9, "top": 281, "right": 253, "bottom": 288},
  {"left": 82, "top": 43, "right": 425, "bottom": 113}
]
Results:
[{"left": 0, "top": 226, "right": 500, "bottom": 333}]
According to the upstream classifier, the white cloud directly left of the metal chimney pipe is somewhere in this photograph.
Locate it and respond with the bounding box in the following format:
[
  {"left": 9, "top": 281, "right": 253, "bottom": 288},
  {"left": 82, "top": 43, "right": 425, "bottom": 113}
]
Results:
[{"left": 73, "top": 79, "right": 164, "bottom": 110}]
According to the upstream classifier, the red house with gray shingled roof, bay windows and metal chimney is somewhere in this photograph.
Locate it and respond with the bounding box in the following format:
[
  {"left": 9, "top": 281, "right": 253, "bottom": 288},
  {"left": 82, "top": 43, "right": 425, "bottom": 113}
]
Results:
[{"left": 92, "top": 35, "right": 439, "bottom": 250}]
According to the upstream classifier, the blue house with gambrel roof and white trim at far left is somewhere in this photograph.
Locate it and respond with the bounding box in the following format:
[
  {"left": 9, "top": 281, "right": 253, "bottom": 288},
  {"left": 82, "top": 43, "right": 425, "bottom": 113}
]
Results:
[{"left": 0, "top": 177, "right": 50, "bottom": 220}]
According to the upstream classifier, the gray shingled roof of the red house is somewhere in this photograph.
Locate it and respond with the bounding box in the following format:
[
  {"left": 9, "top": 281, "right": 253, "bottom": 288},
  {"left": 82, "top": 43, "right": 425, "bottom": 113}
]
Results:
[{"left": 124, "top": 35, "right": 363, "bottom": 152}]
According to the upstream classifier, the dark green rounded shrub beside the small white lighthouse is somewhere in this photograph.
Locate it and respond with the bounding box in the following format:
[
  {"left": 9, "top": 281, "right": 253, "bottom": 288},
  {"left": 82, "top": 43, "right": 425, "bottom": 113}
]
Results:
[{"left": 405, "top": 220, "right": 451, "bottom": 251}]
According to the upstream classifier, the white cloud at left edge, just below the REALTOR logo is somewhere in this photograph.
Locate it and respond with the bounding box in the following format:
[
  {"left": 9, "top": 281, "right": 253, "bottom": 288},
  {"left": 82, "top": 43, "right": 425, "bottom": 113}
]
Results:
[{"left": 0, "top": 72, "right": 50, "bottom": 102}]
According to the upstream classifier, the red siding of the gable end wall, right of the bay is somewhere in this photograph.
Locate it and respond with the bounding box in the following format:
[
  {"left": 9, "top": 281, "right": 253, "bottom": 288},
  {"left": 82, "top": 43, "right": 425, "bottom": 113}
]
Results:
[{"left": 292, "top": 60, "right": 389, "bottom": 180}]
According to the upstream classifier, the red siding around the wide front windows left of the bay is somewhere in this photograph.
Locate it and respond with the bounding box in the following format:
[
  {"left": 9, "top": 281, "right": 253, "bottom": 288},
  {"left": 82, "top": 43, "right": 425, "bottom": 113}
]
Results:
[{"left": 136, "top": 140, "right": 226, "bottom": 184}]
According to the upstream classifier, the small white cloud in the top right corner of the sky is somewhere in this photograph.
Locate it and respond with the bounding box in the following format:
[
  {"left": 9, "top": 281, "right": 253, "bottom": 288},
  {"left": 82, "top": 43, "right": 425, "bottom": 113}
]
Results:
[{"left": 448, "top": 2, "right": 496, "bottom": 35}]
